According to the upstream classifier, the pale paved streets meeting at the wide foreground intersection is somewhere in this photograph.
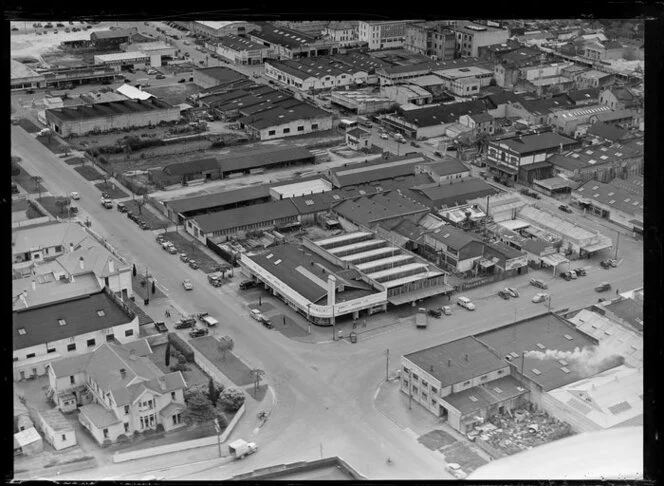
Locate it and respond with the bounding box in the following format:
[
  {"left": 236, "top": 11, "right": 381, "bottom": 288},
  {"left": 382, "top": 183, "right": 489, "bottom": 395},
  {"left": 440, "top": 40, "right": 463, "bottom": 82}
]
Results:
[{"left": 12, "top": 119, "right": 643, "bottom": 479}]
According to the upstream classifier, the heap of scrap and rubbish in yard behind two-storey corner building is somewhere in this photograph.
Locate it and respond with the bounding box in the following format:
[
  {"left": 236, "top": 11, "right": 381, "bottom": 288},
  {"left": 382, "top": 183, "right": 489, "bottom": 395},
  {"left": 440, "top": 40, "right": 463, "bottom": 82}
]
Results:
[{"left": 469, "top": 408, "right": 573, "bottom": 455}]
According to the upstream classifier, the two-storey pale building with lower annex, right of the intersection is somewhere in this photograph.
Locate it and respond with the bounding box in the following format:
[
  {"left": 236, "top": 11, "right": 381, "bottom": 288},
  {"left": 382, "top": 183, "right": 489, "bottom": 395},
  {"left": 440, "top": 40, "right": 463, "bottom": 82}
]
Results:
[{"left": 399, "top": 336, "right": 528, "bottom": 433}]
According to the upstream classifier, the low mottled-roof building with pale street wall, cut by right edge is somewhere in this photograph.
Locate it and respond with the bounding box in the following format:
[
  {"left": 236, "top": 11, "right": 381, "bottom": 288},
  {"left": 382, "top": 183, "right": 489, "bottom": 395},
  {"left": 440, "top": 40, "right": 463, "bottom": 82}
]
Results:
[{"left": 572, "top": 178, "right": 643, "bottom": 233}]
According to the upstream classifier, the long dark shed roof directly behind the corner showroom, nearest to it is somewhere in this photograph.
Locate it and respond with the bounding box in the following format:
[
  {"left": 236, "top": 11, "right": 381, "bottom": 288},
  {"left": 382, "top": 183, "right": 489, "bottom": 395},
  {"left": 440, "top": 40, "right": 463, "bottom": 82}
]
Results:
[{"left": 193, "top": 199, "right": 298, "bottom": 233}]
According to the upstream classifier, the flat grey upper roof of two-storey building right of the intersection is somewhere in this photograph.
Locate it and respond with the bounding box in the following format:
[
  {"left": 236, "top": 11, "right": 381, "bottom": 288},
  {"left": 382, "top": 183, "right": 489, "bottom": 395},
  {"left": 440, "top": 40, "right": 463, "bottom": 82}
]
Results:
[{"left": 404, "top": 336, "right": 507, "bottom": 387}]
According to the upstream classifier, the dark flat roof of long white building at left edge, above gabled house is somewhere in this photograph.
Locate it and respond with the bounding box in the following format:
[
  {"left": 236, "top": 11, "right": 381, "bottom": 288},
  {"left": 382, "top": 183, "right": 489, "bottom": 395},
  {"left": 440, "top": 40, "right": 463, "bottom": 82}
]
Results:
[{"left": 12, "top": 292, "right": 132, "bottom": 350}]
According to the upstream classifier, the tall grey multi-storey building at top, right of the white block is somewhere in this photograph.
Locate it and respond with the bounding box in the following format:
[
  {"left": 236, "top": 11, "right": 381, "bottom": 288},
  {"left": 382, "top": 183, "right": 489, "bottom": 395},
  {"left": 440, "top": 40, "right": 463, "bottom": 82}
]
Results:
[{"left": 403, "top": 21, "right": 456, "bottom": 61}]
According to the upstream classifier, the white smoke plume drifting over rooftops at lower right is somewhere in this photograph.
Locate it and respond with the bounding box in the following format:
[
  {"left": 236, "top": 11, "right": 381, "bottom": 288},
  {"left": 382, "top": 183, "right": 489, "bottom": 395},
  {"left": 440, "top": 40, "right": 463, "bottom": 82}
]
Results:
[{"left": 526, "top": 343, "right": 625, "bottom": 378}]
